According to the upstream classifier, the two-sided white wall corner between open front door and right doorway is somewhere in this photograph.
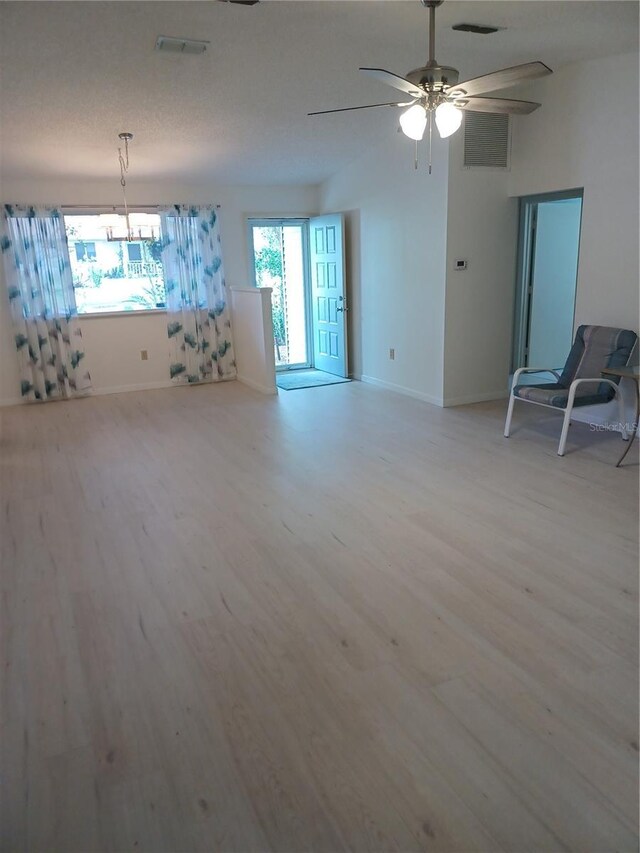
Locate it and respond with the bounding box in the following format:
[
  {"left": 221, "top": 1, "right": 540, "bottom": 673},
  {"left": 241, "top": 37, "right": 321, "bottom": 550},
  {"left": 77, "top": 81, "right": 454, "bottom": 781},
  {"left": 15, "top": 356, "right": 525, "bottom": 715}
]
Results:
[{"left": 320, "top": 122, "right": 517, "bottom": 405}]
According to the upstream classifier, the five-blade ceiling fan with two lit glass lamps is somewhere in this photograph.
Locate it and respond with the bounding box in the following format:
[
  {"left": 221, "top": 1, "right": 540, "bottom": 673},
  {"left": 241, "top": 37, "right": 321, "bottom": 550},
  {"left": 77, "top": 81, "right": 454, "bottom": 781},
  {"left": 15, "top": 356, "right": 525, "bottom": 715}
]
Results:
[{"left": 308, "top": 0, "right": 552, "bottom": 171}]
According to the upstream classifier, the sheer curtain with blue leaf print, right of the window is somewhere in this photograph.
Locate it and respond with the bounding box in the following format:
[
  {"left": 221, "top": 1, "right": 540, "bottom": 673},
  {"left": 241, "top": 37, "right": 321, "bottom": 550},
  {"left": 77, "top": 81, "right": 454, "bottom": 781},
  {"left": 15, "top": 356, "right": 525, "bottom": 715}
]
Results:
[{"left": 160, "top": 204, "right": 236, "bottom": 383}]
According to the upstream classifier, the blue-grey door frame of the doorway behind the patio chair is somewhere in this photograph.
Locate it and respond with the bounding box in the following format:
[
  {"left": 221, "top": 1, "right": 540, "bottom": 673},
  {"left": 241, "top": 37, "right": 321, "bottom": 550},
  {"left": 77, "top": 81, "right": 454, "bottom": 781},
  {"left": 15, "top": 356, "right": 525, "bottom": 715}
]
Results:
[{"left": 511, "top": 187, "right": 584, "bottom": 373}]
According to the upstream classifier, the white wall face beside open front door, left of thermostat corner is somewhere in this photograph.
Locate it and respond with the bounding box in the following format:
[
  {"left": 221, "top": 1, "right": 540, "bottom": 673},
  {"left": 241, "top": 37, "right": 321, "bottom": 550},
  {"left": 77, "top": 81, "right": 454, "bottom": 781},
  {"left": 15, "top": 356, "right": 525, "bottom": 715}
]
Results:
[{"left": 320, "top": 133, "right": 448, "bottom": 404}]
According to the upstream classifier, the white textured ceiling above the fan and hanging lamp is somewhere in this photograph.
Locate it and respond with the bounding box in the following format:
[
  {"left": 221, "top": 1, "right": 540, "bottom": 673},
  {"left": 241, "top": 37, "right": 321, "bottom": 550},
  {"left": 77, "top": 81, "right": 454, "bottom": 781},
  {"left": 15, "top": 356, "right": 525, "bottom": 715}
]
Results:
[{"left": 0, "top": 0, "right": 638, "bottom": 185}]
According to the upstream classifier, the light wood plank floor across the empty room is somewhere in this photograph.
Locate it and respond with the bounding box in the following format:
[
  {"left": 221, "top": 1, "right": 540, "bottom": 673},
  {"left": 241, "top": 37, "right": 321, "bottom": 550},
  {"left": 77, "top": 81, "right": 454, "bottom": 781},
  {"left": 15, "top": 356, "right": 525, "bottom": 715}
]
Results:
[{"left": 0, "top": 382, "right": 638, "bottom": 853}]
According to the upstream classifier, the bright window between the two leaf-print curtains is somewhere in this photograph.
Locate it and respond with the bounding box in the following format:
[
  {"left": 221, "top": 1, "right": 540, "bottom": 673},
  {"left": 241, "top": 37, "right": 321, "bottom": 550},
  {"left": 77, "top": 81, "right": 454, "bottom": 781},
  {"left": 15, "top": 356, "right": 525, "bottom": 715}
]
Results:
[{"left": 64, "top": 214, "right": 166, "bottom": 314}]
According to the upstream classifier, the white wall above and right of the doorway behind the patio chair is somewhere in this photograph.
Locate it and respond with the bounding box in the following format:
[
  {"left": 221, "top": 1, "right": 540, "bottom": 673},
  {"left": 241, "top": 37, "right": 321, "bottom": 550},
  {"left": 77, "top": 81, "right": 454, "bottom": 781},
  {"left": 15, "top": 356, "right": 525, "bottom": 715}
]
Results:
[{"left": 509, "top": 53, "right": 639, "bottom": 422}]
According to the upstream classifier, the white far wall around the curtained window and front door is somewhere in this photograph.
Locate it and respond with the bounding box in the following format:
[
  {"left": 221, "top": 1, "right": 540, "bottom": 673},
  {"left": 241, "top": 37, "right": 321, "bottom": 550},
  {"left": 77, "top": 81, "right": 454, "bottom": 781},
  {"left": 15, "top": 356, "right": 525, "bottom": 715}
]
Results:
[{"left": 0, "top": 177, "right": 318, "bottom": 404}]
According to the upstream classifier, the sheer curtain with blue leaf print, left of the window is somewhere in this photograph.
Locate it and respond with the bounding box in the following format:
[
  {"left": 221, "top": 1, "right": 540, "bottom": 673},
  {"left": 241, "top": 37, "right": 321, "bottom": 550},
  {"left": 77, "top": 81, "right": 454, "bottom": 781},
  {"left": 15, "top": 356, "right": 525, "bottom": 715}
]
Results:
[{"left": 0, "top": 205, "right": 91, "bottom": 400}]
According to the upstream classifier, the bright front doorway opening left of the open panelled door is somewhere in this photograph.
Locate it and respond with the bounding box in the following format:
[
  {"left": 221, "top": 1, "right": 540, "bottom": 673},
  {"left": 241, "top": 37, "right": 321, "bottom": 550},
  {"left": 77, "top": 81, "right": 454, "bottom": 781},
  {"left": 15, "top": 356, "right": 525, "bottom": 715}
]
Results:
[{"left": 249, "top": 219, "right": 312, "bottom": 370}]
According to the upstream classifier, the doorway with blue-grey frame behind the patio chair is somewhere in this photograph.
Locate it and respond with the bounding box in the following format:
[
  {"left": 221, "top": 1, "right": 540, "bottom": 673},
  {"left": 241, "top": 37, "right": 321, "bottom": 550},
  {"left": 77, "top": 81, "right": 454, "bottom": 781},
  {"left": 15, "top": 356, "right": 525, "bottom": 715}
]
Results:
[{"left": 512, "top": 190, "right": 582, "bottom": 370}]
